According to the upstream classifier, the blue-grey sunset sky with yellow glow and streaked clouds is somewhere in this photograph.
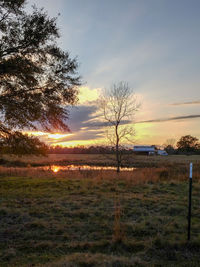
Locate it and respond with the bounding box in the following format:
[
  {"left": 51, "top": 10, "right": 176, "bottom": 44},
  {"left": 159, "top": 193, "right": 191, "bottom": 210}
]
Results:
[{"left": 27, "top": 0, "right": 200, "bottom": 146}]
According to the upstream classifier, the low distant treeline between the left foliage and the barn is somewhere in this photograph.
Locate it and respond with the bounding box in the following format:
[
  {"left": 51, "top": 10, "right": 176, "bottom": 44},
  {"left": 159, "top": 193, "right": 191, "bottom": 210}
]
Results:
[{"left": 48, "top": 146, "right": 133, "bottom": 154}]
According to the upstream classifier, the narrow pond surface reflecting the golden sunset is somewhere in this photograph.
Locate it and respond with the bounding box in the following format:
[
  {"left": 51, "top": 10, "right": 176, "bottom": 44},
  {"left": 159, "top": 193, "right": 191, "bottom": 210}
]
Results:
[{"left": 43, "top": 165, "right": 135, "bottom": 173}]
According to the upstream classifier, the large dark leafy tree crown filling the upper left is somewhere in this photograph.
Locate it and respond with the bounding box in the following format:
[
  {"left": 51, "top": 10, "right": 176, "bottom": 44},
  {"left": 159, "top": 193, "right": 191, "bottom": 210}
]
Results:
[{"left": 0, "top": 0, "right": 81, "bottom": 154}]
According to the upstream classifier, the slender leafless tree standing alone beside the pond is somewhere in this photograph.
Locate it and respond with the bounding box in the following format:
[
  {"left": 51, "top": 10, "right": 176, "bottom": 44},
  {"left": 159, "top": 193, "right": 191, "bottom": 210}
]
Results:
[{"left": 100, "top": 82, "right": 139, "bottom": 172}]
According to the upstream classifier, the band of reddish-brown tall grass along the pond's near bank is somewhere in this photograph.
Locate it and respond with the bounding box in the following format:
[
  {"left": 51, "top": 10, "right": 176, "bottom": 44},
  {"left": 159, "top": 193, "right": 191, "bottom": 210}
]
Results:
[{"left": 0, "top": 166, "right": 200, "bottom": 185}]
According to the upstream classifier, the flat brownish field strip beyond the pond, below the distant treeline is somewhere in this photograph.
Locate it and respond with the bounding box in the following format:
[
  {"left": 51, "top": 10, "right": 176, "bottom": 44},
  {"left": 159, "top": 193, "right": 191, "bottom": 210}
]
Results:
[{"left": 2, "top": 154, "right": 200, "bottom": 167}]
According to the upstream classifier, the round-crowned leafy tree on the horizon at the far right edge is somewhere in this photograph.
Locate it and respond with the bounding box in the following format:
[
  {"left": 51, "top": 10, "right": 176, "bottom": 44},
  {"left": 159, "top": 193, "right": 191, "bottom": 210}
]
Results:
[{"left": 176, "top": 135, "right": 200, "bottom": 152}]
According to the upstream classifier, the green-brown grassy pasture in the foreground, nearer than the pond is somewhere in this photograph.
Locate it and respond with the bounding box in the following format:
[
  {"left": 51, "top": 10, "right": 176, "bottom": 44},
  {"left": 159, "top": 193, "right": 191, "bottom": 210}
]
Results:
[{"left": 0, "top": 168, "right": 200, "bottom": 267}]
